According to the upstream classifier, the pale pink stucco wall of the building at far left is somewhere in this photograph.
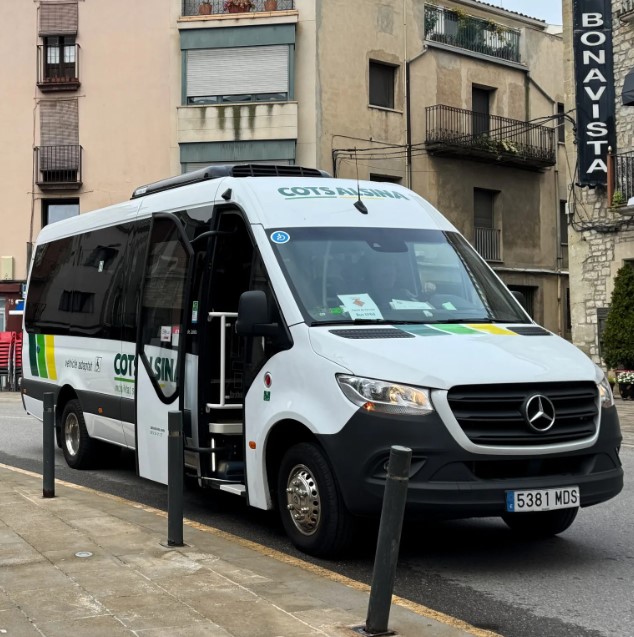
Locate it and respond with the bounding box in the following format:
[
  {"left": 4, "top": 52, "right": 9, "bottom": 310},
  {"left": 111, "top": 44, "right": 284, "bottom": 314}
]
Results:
[{"left": 0, "top": 0, "right": 181, "bottom": 280}]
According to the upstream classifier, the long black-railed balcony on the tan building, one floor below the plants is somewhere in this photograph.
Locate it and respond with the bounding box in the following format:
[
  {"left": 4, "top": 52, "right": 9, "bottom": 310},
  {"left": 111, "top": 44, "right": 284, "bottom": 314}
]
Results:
[{"left": 425, "top": 104, "right": 556, "bottom": 170}]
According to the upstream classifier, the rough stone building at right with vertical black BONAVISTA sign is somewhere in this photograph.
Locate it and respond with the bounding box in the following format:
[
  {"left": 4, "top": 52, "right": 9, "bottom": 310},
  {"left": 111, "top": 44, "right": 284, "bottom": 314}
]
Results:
[{"left": 563, "top": 0, "right": 634, "bottom": 364}]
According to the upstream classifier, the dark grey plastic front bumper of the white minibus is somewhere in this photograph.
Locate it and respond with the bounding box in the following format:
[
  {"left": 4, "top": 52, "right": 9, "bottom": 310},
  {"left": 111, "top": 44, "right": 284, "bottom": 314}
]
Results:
[{"left": 319, "top": 407, "right": 623, "bottom": 519}]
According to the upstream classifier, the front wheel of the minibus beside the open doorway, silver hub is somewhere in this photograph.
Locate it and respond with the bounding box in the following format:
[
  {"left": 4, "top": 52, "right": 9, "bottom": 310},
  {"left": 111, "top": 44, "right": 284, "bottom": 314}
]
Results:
[{"left": 277, "top": 442, "right": 353, "bottom": 557}]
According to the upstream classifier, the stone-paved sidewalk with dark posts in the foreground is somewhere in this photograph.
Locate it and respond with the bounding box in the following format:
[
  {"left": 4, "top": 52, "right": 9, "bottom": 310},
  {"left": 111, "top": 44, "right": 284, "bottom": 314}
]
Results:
[{"left": 0, "top": 465, "right": 486, "bottom": 637}]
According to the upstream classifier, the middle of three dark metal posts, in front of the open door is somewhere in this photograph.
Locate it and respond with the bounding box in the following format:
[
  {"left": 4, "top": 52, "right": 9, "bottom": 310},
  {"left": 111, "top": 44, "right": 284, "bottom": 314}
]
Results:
[{"left": 167, "top": 411, "right": 183, "bottom": 546}]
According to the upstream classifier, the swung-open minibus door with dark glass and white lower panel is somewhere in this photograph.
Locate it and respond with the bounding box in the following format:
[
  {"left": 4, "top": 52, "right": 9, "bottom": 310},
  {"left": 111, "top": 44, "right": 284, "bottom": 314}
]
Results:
[{"left": 135, "top": 214, "right": 192, "bottom": 484}]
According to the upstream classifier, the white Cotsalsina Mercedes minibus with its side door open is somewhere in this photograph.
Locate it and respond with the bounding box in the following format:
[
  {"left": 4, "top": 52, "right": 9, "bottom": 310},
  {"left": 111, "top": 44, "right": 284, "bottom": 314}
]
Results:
[{"left": 22, "top": 165, "right": 623, "bottom": 556}]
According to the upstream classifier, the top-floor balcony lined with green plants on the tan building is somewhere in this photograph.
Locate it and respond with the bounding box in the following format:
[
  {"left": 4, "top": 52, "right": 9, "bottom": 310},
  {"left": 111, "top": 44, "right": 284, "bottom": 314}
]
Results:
[{"left": 425, "top": 4, "right": 520, "bottom": 63}]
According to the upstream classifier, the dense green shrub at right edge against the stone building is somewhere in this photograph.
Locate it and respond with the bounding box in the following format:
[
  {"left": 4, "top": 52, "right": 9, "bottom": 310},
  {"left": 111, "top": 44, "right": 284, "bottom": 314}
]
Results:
[{"left": 601, "top": 265, "right": 634, "bottom": 397}]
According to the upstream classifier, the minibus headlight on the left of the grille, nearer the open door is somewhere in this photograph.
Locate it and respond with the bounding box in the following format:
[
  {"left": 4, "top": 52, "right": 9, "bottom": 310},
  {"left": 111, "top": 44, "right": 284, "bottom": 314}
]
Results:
[{"left": 337, "top": 374, "right": 434, "bottom": 416}]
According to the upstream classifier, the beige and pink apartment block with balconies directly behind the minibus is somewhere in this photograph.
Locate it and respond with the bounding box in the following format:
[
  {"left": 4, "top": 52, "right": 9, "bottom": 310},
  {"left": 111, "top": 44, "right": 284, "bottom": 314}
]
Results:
[{"left": 0, "top": 0, "right": 570, "bottom": 336}]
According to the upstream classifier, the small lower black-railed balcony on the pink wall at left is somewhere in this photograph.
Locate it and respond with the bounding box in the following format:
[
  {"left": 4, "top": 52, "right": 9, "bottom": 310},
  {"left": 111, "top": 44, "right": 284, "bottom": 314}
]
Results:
[{"left": 35, "top": 144, "right": 82, "bottom": 190}]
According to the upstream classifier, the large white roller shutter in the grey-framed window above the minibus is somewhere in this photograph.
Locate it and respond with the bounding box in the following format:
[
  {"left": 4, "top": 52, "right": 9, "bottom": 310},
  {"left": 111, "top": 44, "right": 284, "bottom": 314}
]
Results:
[{"left": 187, "top": 46, "right": 288, "bottom": 97}]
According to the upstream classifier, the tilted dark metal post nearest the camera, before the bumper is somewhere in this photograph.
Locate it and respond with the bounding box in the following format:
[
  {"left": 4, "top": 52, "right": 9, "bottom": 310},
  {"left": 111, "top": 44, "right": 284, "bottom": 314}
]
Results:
[{"left": 365, "top": 446, "right": 412, "bottom": 635}]
